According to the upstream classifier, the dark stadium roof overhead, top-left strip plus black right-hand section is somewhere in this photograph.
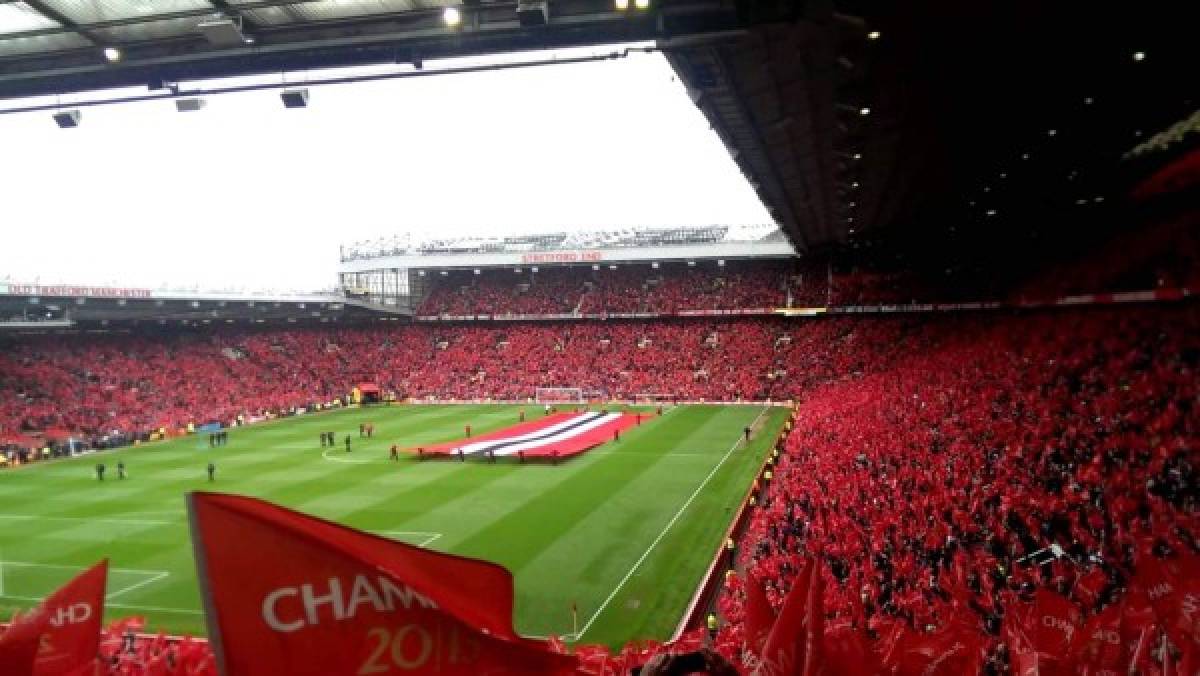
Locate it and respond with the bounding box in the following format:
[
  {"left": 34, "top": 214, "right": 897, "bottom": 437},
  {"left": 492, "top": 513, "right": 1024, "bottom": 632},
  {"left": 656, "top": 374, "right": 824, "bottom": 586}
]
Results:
[{"left": 0, "top": 0, "right": 1196, "bottom": 256}]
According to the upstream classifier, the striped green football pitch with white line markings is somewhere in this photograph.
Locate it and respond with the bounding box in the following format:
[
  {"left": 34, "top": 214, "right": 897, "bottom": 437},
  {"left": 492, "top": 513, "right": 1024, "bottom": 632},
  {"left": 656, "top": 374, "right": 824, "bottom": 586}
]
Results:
[{"left": 0, "top": 405, "right": 786, "bottom": 645}]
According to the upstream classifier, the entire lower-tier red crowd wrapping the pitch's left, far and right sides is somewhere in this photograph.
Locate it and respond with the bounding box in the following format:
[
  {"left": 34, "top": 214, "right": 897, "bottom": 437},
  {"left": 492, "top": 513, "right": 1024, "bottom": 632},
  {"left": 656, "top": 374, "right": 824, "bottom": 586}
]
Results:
[{"left": 0, "top": 303, "right": 1200, "bottom": 674}]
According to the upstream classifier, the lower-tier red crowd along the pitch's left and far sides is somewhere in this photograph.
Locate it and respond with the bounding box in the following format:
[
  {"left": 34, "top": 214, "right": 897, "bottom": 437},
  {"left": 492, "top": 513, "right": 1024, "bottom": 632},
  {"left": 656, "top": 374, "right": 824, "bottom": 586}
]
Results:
[{"left": 0, "top": 319, "right": 902, "bottom": 437}]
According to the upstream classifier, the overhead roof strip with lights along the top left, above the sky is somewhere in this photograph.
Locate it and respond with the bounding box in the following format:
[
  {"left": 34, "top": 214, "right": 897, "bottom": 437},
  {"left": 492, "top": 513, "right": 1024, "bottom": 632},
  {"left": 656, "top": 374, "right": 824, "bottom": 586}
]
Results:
[{"left": 0, "top": 0, "right": 737, "bottom": 97}]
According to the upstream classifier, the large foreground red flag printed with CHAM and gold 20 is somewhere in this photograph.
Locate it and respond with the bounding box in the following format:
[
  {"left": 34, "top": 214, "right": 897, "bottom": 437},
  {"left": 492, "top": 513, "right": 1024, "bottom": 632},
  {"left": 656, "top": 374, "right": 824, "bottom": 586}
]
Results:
[{"left": 188, "top": 492, "right": 577, "bottom": 676}]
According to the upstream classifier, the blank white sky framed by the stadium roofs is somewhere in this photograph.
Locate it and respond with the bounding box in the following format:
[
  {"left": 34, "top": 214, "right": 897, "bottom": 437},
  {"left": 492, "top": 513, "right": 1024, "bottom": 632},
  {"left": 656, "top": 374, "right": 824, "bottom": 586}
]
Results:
[{"left": 0, "top": 48, "right": 770, "bottom": 291}]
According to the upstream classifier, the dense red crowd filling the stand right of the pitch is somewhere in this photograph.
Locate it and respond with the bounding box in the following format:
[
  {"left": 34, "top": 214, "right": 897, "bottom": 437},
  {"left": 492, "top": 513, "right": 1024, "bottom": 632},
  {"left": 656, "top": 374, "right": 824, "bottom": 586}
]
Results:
[{"left": 718, "top": 306, "right": 1200, "bottom": 674}]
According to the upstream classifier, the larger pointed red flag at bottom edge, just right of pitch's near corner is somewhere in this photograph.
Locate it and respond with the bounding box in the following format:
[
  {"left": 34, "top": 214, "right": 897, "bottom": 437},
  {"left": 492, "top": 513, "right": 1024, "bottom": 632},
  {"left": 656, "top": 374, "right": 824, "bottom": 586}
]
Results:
[{"left": 754, "top": 558, "right": 824, "bottom": 676}]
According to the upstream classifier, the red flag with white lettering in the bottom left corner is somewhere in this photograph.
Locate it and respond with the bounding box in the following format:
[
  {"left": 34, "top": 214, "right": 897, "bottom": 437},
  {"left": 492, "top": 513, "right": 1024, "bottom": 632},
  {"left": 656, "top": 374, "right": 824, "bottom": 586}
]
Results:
[{"left": 0, "top": 558, "right": 108, "bottom": 676}]
